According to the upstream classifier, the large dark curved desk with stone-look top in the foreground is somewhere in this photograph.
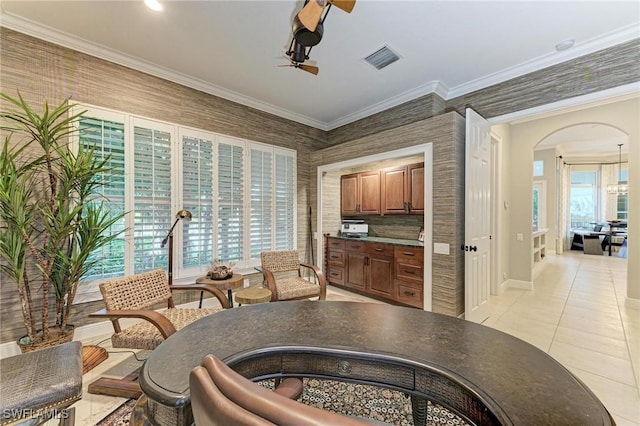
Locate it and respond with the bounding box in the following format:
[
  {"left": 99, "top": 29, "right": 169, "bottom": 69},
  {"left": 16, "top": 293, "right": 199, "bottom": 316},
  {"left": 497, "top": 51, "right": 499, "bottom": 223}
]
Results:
[{"left": 140, "top": 301, "right": 615, "bottom": 426}]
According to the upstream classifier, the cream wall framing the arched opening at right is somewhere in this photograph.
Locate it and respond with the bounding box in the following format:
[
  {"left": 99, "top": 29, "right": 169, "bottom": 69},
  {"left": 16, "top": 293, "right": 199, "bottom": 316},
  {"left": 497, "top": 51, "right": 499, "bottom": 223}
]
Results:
[{"left": 503, "top": 98, "right": 640, "bottom": 306}]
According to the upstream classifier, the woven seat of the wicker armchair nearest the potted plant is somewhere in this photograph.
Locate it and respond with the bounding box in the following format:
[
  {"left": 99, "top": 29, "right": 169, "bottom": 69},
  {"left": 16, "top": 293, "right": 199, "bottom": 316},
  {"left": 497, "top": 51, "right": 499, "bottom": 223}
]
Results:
[{"left": 111, "top": 308, "right": 222, "bottom": 350}]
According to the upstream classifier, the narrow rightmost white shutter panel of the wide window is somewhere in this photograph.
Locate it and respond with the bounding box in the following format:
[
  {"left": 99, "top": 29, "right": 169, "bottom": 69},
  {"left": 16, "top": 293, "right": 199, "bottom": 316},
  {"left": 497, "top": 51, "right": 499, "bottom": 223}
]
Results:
[{"left": 274, "top": 152, "right": 296, "bottom": 250}]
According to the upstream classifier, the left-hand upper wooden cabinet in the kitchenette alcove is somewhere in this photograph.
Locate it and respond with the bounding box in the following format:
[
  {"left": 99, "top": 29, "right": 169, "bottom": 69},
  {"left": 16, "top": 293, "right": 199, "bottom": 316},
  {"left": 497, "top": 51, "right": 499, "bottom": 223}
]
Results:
[{"left": 340, "top": 171, "right": 380, "bottom": 216}]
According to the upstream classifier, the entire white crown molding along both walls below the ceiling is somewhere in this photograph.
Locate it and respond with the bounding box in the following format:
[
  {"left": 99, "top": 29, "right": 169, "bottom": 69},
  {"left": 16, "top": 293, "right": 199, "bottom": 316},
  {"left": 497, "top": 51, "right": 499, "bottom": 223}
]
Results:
[{"left": 0, "top": 12, "right": 640, "bottom": 131}]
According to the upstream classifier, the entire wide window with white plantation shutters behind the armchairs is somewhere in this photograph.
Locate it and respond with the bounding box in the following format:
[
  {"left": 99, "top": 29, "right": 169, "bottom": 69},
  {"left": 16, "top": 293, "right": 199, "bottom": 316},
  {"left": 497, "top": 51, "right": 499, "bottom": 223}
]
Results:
[{"left": 77, "top": 106, "right": 297, "bottom": 292}]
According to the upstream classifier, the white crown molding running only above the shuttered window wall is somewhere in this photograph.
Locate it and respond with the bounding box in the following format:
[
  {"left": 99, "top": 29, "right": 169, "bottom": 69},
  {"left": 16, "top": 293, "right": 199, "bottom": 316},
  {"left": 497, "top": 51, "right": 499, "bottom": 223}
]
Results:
[{"left": 0, "top": 12, "right": 327, "bottom": 130}]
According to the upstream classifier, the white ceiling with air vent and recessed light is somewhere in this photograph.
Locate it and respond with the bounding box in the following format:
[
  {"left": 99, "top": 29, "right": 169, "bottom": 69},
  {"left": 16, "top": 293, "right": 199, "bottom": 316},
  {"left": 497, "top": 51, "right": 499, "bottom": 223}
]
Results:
[{"left": 1, "top": 0, "right": 640, "bottom": 155}]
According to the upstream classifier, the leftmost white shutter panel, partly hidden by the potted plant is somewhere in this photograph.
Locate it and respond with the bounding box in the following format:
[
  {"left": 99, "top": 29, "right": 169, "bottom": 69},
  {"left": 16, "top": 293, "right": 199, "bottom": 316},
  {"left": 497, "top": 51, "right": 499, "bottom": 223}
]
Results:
[{"left": 78, "top": 112, "right": 125, "bottom": 281}]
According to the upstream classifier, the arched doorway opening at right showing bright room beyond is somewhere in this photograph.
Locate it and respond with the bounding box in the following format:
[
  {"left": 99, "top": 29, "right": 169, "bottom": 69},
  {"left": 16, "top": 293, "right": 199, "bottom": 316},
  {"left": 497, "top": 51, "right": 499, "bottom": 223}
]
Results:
[{"left": 533, "top": 122, "right": 629, "bottom": 254}]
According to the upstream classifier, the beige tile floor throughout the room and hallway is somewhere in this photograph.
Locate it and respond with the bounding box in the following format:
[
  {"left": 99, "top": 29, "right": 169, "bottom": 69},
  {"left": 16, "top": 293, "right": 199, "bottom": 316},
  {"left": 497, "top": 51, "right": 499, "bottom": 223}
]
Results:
[{"left": 67, "top": 252, "right": 640, "bottom": 426}]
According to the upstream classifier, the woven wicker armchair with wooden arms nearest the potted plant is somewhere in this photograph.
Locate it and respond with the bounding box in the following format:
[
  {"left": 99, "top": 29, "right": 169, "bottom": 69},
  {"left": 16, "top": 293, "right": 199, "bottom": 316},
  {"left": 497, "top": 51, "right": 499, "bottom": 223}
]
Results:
[{"left": 89, "top": 269, "right": 230, "bottom": 398}]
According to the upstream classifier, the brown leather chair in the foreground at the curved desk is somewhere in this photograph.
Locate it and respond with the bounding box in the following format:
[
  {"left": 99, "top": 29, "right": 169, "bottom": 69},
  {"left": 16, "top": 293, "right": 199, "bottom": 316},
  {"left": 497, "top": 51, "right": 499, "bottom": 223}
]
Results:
[{"left": 189, "top": 355, "right": 371, "bottom": 426}]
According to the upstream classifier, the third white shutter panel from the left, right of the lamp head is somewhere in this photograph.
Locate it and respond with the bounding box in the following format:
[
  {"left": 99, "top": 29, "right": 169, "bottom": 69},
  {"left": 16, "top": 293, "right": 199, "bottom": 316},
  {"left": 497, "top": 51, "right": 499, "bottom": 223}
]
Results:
[{"left": 182, "top": 135, "right": 214, "bottom": 269}]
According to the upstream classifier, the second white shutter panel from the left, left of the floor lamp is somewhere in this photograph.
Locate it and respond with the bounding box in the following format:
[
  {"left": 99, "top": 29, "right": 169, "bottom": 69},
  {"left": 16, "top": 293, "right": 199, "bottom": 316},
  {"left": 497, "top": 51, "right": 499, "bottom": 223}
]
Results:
[{"left": 133, "top": 120, "right": 173, "bottom": 273}]
